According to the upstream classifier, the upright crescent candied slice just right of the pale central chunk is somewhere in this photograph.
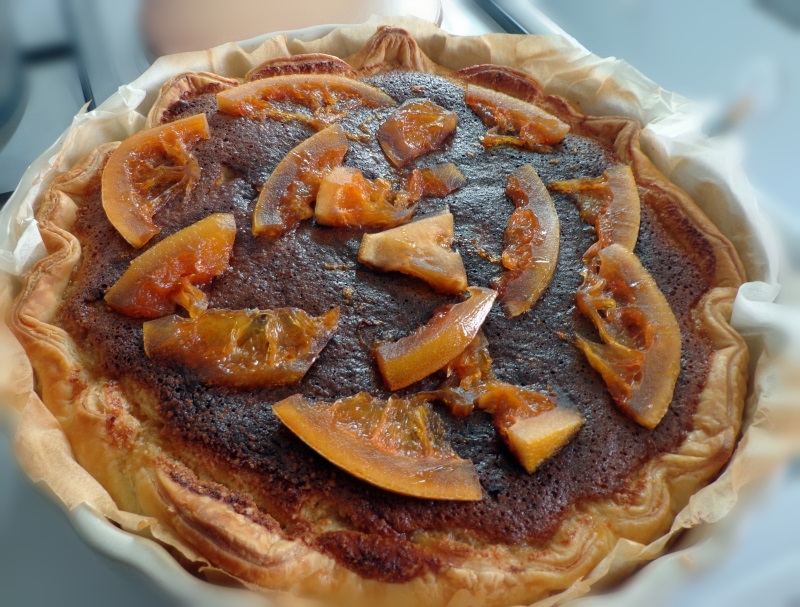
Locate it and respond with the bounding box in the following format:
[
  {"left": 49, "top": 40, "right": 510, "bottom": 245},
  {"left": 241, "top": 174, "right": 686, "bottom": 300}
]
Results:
[{"left": 496, "top": 164, "right": 561, "bottom": 317}]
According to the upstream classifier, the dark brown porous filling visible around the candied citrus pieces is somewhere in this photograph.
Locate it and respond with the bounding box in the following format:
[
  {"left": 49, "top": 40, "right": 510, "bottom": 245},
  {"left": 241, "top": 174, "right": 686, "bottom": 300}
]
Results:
[{"left": 61, "top": 72, "right": 711, "bottom": 581}]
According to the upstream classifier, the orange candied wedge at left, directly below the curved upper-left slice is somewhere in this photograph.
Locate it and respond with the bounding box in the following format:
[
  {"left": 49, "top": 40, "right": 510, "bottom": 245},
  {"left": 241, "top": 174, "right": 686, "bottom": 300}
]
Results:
[{"left": 105, "top": 213, "right": 236, "bottom": 318}]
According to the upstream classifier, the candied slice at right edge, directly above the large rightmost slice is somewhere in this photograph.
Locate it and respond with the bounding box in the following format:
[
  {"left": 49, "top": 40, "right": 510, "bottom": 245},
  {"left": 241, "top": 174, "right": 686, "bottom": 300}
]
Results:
[{"left": 547, "top": 165, "right": 641, "bottom": 257}]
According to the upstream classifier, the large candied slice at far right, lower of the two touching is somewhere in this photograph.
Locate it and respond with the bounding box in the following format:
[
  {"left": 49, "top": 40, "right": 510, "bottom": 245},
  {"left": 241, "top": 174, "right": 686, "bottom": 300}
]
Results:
[{"left": 576, "top": 244, "right": 681, "bottom": 428}]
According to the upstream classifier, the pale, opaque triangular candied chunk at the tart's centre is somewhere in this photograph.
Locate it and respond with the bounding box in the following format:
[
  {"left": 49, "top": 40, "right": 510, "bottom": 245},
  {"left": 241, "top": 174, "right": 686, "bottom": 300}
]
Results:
[{"left": 358, "top": 210, "right": 468, "bottom": 293}]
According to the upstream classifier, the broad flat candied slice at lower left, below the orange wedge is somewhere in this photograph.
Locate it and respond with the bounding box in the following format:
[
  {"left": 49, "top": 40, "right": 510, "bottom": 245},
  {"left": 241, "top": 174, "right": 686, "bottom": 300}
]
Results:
[{"left": 144, "top": 308, "right": 339, "bottom": 388}]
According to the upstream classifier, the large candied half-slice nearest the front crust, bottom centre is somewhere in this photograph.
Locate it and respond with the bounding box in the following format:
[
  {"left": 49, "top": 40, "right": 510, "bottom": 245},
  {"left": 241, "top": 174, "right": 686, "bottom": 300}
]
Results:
[{"left": 273, "top": 393, "right": 482, "bottom": 501}]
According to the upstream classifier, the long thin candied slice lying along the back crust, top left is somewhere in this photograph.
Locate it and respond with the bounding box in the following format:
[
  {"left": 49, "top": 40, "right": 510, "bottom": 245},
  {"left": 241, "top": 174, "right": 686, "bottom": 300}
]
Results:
[{"left": 217, "top": 74, "right": 397, "bottom": 120}]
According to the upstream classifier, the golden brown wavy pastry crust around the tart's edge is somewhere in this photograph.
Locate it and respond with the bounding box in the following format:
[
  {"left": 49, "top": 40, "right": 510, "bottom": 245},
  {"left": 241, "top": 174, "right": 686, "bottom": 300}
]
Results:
[{"left": 11, "top": 28, "right": 747, "bottom": 605}]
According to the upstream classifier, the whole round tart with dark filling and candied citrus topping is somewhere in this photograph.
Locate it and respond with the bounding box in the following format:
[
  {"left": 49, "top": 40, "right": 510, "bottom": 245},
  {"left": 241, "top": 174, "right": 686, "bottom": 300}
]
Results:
[{"left": 10, "top": 27, "right": 747, "bottom": 605}]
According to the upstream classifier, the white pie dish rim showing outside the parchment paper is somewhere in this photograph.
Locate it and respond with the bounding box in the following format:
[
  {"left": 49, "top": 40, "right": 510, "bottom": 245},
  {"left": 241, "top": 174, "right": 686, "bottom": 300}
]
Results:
[{"left": 0, "top": 16, "right": 778, "bottom": 607}]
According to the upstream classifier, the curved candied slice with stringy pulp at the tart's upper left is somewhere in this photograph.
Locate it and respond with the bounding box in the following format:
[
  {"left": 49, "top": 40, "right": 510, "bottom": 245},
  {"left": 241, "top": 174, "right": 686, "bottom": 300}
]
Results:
[{"left": 102, "top": 114, "right": 210, "bottom": 249}]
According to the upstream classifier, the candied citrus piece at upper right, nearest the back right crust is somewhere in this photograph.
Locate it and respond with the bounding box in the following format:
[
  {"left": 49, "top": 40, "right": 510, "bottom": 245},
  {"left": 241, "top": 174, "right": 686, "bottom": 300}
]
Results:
[{"left": 465, "top": 84, "right": 569, "bottom": 151}]
